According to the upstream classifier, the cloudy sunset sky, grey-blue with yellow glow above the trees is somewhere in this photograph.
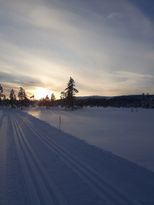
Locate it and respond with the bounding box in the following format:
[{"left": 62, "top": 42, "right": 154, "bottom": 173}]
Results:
[{"left": 0, "top": 0, "right": 154, "bottom": 98}]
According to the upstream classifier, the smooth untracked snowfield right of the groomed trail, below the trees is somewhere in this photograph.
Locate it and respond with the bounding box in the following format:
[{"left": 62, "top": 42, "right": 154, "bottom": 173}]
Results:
[{"left": 27, "top": 108, "right": 154, "bottom": 171}]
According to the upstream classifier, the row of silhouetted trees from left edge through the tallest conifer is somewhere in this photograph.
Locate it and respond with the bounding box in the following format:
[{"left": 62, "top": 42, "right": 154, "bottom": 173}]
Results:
[{"left": 0, "top": 77, "right": 78, "bottom": 110}]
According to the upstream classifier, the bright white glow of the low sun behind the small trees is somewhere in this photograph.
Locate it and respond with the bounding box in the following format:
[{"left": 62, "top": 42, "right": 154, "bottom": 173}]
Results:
[{"left": 34, "top": 87, "right": 52, "bottom": 100}]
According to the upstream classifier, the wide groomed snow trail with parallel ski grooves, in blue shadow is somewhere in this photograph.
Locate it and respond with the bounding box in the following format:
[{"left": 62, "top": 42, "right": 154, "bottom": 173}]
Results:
[{"left": 0, "top": 110, "right": 154, "bottom": 205}]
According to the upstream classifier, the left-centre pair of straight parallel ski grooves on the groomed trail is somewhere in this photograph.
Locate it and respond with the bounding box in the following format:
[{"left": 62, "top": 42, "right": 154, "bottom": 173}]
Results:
[{"left": 11, "top": 113, "right": 68, "bottom": 205}]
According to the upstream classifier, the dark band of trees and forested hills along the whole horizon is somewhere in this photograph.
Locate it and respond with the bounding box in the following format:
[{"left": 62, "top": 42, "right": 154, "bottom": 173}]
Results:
[{"left": 0, "top": 77, "right": 154, "bottom": 110}]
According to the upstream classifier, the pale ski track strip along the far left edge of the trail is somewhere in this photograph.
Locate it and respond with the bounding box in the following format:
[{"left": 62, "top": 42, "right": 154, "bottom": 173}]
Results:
[{"left": 0, "top": 112, "right": 29, "bottom": 205}]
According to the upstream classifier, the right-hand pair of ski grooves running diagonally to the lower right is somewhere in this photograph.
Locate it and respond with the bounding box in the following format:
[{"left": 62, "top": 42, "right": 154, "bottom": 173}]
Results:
[{"left": 18, "top": 115, "right": 141, "bottom": 205}]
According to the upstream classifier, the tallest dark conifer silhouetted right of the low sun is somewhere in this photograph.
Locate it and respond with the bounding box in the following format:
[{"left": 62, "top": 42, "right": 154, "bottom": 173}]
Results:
[{"left": 65, "top": 77, "right": 78, "bottom": 110}]
